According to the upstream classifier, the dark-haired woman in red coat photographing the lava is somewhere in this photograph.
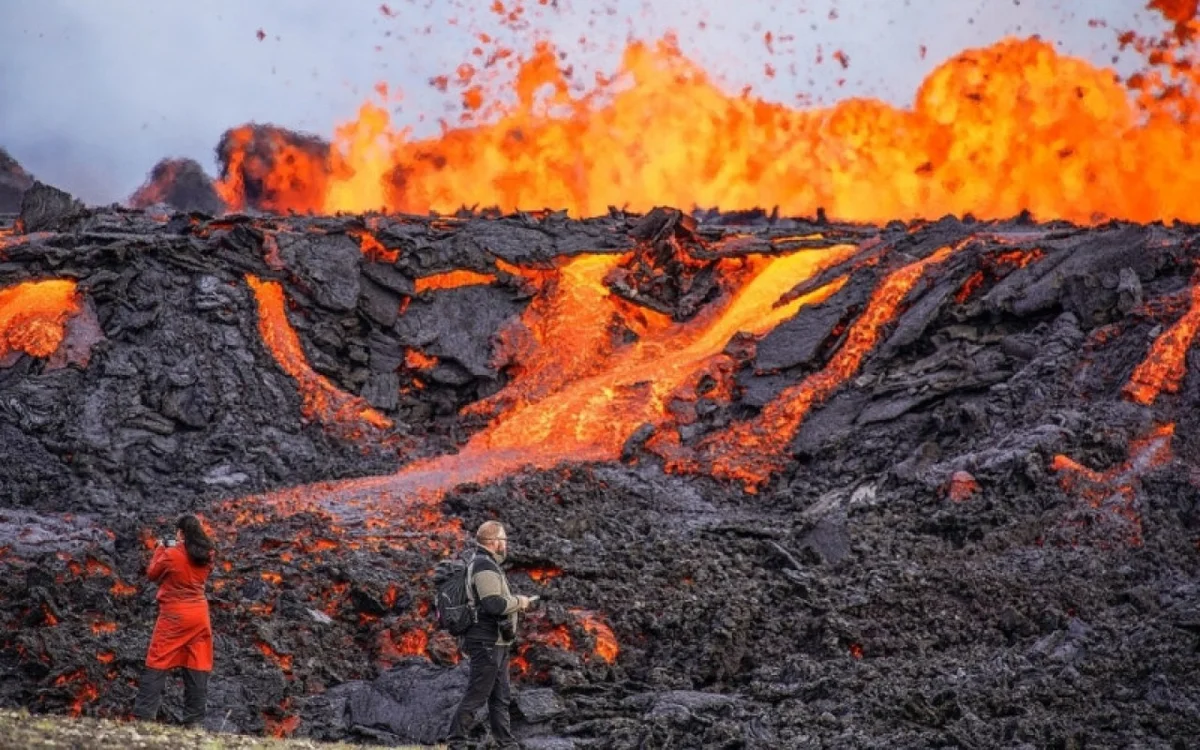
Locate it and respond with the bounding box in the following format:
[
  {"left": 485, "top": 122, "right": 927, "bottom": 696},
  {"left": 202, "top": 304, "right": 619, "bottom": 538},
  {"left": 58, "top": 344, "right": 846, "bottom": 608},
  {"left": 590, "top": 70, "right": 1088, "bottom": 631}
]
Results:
[{"left": 133, "top": 515, "right": 216, "bottom": 724}]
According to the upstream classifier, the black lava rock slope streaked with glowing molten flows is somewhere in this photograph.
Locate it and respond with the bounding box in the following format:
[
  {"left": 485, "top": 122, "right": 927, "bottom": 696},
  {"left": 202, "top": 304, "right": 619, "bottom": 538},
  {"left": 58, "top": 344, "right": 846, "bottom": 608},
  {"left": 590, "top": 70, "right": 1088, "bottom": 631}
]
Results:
[{"left": 0, "top": 194, "right": 1200, "bottom": 748}]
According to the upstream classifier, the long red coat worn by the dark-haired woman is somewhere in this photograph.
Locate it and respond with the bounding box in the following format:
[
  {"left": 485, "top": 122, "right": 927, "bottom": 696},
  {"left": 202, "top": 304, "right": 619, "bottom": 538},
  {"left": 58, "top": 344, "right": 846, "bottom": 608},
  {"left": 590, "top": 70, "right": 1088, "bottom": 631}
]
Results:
[{"left": 146, "top": 545, "right": 212, "bottom": 672}]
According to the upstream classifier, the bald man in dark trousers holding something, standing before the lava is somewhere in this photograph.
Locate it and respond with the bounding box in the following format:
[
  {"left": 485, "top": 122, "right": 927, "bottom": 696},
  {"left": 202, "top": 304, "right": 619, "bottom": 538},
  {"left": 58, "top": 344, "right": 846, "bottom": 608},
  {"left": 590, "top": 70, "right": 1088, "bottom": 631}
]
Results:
[{"left": 449, "top": 521, "right": 536, "bottom": 750}]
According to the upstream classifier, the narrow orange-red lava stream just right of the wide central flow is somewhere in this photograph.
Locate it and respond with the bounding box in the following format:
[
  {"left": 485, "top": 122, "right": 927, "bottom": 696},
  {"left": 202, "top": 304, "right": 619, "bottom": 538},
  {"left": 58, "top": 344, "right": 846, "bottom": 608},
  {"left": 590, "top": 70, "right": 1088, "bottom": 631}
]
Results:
[{"left": 652, "top": 245, "right": 961, "bottom": 491}]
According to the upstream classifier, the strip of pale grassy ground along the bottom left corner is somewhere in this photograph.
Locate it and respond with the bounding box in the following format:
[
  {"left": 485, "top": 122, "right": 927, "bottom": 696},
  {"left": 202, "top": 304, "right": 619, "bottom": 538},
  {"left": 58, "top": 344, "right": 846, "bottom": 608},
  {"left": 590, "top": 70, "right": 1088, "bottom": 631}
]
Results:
[{"left": 0, "top": 709, "right": 444, "bottom": 750}]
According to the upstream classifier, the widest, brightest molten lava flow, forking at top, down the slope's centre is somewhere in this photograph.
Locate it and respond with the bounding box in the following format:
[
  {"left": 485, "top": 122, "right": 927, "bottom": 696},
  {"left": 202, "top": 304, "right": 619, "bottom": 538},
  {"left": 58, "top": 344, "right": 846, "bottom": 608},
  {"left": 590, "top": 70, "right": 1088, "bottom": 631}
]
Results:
[{"left": 218, "top": 245, "right": 856, "bottom": 518}]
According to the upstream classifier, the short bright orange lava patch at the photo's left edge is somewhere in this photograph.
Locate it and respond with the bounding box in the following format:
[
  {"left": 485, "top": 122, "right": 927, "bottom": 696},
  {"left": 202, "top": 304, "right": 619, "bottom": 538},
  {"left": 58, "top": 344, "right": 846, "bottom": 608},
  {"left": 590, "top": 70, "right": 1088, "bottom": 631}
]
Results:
[{"left": 0, "top": 280, "right": 79, "bottom": 360}]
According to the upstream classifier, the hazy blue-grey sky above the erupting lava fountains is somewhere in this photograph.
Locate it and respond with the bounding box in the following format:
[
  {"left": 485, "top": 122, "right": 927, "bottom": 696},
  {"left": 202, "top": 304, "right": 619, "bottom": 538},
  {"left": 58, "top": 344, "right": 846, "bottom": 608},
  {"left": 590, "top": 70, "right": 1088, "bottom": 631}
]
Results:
[{"left": 0, "top": 0, "right": 1162, "bottom": 203}]
